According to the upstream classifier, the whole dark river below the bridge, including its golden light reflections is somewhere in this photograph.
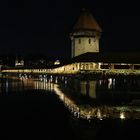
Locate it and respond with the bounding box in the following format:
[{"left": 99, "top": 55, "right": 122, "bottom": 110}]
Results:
[{"left": 0, "top": 77, "right": 140, "bottom": 140}]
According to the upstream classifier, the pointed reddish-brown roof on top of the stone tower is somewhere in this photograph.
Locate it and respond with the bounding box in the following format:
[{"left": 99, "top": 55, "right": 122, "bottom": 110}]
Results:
[{"left": 73, "top": 9, "right": 102, "bottom": 32}]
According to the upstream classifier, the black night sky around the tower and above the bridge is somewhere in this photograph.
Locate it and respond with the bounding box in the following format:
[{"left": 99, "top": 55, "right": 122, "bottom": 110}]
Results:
[{"left": 0, "top": 0, "right": 140, "bottom": 57}]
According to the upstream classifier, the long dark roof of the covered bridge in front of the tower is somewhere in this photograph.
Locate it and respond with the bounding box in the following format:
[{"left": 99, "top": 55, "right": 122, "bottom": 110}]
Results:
[{"left": 72, "top": 52, "right": 140, "bottom": 64}]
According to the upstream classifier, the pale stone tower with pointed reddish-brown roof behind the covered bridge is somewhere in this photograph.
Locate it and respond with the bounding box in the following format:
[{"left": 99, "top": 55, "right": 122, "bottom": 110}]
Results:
[{"left": 70, "top": 9, "right": 102, "bottom": 58}]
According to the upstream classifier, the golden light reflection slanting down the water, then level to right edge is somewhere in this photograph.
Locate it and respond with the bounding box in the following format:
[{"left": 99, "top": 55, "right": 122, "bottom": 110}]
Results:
[{"left": 53, "top": 84, "right": 140, "bottom": 120}]
